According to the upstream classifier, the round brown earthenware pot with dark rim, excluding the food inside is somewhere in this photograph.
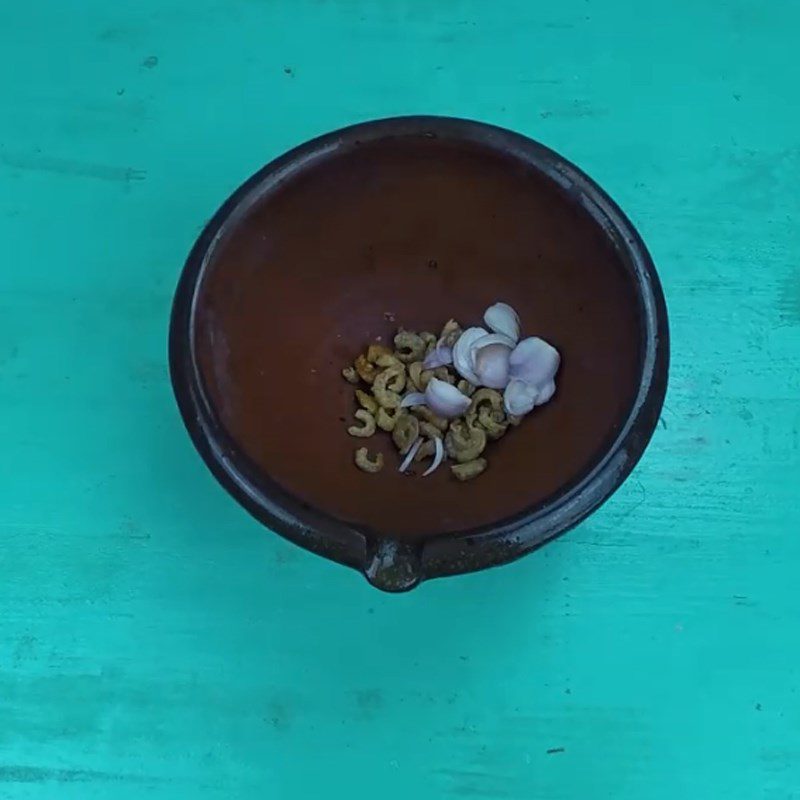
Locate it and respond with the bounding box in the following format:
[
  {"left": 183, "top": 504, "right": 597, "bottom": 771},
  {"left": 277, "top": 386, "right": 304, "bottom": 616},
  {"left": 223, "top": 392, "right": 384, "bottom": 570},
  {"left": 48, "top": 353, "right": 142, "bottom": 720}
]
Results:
[{"left": 169, "top": 116, "right": 669, "bottom": 591}]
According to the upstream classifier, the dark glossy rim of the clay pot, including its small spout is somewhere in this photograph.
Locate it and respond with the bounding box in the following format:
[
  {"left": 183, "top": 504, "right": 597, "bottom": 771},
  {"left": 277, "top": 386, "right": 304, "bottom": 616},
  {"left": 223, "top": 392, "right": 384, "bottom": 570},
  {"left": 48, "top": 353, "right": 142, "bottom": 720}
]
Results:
[{"left": 169, "top": 116, "right": 669, "bottom": 591}]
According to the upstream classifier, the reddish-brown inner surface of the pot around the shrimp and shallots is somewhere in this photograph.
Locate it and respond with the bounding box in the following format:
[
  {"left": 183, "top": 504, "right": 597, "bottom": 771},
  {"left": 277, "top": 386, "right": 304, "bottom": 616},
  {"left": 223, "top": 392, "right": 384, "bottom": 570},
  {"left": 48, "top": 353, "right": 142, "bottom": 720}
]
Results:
[{"left": 193, "top": 138, "right": 641, "bottom": 540}]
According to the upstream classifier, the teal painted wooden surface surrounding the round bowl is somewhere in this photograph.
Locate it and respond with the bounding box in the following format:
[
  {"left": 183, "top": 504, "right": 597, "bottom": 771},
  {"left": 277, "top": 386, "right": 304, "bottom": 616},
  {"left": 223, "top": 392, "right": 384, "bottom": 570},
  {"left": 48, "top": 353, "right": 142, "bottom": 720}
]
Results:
[{"left": 0, "top": 0, "right": 800, "bottom": 800}]
